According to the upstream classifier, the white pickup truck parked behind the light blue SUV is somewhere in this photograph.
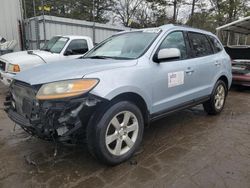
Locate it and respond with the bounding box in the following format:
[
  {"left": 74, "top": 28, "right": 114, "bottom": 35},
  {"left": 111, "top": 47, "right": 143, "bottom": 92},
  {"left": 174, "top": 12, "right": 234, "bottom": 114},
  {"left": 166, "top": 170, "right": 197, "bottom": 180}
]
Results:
[{"left": 0, "top": 35, "right": 94, "bottom": 86}]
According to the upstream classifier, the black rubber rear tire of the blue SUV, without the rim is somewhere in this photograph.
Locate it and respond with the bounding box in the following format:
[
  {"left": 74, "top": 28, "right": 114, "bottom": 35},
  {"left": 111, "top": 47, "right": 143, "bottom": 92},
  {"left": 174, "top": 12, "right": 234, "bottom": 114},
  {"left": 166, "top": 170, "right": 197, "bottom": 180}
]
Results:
[{"left": 203, "top": 80, "right": 228, "bottom": 115}]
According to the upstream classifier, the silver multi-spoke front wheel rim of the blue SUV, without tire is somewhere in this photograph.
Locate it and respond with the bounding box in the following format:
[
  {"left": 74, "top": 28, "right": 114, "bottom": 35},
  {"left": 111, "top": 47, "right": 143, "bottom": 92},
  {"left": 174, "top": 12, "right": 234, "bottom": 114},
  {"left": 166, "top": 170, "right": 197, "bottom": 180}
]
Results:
[{"left": 105, "top": 111, "right": 139, "bottom": 156}]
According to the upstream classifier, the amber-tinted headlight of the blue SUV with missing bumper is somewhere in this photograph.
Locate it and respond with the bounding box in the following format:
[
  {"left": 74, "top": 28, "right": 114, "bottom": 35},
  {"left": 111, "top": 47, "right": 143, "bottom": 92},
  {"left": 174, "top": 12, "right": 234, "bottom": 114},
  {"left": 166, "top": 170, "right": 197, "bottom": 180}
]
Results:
[{"left": 36, "top": 79, "right": 98, "bottom": 100}]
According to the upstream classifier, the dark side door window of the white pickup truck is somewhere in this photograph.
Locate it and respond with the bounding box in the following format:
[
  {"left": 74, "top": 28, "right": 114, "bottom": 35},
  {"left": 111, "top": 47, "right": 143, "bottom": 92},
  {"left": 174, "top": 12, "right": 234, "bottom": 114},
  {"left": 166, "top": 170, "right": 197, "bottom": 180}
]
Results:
[{"left": 66, "top": 39, "right": 88, "bottom": 55}]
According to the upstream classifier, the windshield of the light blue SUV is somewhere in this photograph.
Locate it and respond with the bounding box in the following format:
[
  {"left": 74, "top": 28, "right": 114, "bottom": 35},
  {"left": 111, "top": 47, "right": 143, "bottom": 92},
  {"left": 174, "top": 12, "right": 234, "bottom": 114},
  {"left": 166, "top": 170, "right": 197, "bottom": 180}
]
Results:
[{"left": 84, "top": 30, "right": 158, "bottom": 59}]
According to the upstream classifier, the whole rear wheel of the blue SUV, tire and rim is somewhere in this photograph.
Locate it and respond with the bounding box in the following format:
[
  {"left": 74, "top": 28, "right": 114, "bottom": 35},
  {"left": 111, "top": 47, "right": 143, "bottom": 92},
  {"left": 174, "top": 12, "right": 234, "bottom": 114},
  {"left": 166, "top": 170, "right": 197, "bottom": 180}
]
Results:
[{"left": 203, "top": 80, "right": 228, "bottom": 115}]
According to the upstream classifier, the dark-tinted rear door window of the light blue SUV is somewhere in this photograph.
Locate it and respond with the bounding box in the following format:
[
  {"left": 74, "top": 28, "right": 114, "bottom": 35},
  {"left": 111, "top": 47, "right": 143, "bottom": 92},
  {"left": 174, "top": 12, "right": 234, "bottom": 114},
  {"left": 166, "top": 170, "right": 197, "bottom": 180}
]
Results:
[{"left": 188, "top": 32, "right": 213, "bottom": 57}]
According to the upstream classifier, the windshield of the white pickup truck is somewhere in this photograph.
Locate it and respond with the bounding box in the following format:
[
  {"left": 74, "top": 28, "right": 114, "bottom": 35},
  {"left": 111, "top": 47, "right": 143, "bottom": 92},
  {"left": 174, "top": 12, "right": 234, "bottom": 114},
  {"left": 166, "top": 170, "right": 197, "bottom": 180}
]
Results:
[{"left": 41, "top": 37, "right": 69, "bottom": 54}]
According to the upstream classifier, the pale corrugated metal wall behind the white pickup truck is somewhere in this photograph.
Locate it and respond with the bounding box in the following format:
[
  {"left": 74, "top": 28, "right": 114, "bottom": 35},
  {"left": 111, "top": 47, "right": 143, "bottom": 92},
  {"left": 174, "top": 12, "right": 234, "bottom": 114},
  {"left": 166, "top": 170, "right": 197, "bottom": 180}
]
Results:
[{"left": 24, "top": 15, "right": 131, "bottom": 49}]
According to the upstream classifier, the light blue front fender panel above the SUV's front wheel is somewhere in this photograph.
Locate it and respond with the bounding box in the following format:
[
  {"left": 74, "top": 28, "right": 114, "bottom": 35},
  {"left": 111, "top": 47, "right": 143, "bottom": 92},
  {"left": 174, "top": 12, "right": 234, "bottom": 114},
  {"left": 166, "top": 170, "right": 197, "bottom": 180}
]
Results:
[{"left": 84, "top": 59, "right": 152, "bottom": 111}]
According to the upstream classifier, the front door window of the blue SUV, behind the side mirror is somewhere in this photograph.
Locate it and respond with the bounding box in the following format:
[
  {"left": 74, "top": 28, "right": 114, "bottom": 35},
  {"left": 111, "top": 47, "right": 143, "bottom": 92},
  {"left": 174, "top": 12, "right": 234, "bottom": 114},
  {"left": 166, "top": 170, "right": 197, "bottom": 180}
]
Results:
[{"left": 160, "top": 31, "right": 187, "bottom": 59}]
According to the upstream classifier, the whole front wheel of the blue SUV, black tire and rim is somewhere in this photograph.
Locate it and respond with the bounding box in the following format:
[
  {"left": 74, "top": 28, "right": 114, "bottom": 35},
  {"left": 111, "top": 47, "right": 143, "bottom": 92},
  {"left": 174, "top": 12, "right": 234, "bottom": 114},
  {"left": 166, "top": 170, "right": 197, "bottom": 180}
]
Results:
[{"left": 87, "top": 101, "right": 144, "bottom": 165}]
